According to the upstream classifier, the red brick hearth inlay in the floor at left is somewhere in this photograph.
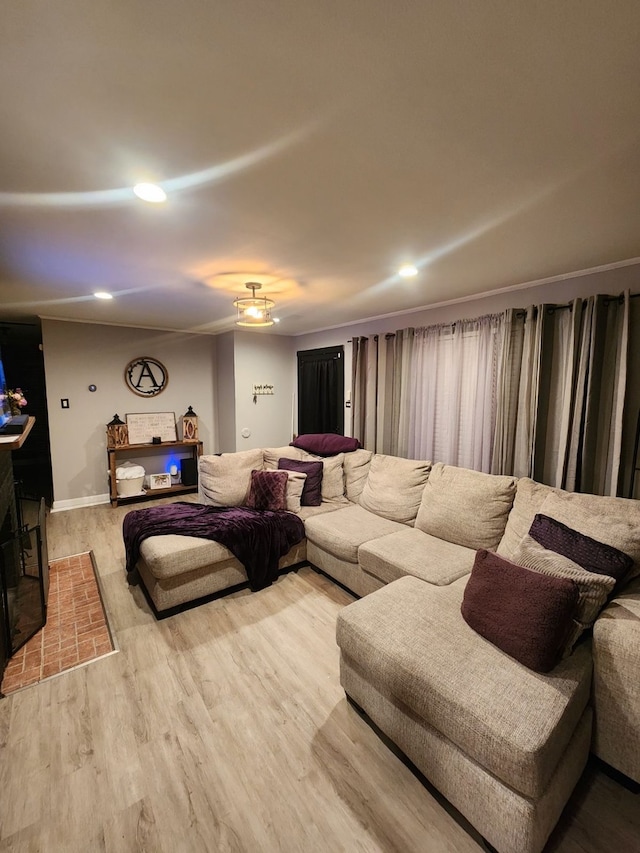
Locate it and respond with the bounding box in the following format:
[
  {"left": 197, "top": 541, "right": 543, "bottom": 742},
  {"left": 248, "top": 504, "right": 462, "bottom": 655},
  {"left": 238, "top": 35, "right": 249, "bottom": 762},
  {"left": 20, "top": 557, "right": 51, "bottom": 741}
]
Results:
[{"left": 2, "top": 552, "right": 114, "bottom": 693}]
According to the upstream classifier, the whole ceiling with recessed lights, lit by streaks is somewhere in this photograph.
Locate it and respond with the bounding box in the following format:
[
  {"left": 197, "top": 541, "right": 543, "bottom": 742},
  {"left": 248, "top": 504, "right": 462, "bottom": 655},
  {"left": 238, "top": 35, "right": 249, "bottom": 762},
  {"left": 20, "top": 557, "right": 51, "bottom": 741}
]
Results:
[{"left": 0, "top": 0, "right": 640, "bottom": 334}]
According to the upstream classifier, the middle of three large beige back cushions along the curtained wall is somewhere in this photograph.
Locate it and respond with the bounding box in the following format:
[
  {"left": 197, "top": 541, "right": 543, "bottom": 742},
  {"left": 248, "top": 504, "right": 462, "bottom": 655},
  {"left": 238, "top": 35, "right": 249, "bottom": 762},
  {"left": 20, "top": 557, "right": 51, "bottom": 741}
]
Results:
[{"left": 416, "top": 462, "right": 516, "bottom": 550}]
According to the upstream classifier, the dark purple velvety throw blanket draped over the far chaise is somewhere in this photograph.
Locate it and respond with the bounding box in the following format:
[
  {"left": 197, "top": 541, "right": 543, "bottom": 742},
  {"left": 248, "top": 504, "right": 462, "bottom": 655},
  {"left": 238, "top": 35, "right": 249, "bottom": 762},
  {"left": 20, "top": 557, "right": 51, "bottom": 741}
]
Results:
[{"left": 122, "top": 503, "right": 304, "bottom": 592}]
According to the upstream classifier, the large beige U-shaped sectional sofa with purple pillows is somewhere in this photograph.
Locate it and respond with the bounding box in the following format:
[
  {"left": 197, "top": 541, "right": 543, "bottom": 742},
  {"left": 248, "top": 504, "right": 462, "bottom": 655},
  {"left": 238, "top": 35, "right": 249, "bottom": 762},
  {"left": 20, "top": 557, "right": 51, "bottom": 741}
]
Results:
[{"left": 131, "top": 447, "right": 640, "bottom": 853}]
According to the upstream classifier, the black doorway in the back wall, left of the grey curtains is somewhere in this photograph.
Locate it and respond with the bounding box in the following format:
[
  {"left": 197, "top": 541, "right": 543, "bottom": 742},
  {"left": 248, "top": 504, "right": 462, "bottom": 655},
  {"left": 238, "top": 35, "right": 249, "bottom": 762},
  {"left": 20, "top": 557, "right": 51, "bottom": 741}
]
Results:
[{"left": 298, "top": 346, "right": 344, "bottom": 435}]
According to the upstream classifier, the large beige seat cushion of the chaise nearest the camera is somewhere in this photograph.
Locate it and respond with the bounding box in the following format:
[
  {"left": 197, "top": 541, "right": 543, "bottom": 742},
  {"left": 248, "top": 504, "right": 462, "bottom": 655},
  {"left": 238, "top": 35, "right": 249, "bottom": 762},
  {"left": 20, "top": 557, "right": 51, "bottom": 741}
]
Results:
[{"left": 337, "top": 577, "right": 591, "bottom": 798}]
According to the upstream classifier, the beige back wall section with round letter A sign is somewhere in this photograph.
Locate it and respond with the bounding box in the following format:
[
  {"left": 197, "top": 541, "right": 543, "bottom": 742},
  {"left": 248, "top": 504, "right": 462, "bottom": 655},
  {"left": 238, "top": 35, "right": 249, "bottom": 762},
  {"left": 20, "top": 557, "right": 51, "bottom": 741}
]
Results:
[{"left": 42, "top": 320, "right": 217, "bottom": 509}]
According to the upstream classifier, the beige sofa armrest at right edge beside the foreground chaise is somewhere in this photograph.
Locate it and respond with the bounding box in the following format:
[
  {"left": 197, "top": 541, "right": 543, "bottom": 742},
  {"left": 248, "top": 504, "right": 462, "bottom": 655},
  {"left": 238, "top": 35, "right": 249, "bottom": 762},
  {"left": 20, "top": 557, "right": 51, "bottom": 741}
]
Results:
[{"left": 593, "top": 578, "right": 640, "bottom": 783}]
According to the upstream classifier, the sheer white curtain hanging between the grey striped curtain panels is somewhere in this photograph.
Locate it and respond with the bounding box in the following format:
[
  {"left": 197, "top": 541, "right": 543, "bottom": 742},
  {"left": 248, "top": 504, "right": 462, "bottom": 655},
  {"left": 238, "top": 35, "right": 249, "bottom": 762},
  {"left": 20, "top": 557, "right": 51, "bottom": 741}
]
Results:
[{"left": 406, "top": 314, "right": 505, "bottom": 471}]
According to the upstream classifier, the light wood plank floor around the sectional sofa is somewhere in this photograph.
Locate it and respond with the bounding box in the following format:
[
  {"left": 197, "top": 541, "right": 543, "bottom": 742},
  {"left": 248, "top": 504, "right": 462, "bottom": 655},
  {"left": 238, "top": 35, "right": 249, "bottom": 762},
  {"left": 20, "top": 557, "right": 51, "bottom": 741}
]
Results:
[{"left": 0, "top": 506, "right": 640, "bottom": 853}]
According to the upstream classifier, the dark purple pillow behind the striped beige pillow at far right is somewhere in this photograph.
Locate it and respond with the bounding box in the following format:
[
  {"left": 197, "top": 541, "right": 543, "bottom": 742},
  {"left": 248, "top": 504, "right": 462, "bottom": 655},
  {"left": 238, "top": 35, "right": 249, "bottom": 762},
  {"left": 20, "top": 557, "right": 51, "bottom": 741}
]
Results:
[{"left": 529, "top": 514, "right": 633, "bottom": 581}]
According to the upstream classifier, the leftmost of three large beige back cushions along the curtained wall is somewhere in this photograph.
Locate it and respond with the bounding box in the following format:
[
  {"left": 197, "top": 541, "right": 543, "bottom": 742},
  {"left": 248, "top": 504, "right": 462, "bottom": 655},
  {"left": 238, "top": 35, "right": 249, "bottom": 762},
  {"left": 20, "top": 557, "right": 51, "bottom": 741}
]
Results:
[{"left": 360, "top": 453, "right": 431, "bottom": 524}]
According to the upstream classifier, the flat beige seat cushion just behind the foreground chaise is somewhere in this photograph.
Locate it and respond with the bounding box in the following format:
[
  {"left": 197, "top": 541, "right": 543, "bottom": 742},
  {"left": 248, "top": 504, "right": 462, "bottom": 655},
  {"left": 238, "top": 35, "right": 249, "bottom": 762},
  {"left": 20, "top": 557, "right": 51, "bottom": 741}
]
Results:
[{"left": 358, "top": 527, "right": 476, "bottom": 586}]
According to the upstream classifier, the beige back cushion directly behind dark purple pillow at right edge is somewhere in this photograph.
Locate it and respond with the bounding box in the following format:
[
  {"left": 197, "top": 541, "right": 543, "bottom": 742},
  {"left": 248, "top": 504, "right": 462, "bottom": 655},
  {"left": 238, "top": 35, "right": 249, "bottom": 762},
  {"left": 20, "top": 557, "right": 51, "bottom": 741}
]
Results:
[{"left": 540, "top": 491, "right": 640, "bottom": 580}]
